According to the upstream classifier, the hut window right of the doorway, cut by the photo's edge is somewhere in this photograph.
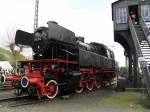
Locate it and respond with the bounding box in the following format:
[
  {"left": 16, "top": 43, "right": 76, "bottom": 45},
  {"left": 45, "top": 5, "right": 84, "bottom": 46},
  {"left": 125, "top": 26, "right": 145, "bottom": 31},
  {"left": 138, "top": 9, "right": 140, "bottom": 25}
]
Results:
[{"left": 141, "top": 5, "right": 150, "bottom": 21}]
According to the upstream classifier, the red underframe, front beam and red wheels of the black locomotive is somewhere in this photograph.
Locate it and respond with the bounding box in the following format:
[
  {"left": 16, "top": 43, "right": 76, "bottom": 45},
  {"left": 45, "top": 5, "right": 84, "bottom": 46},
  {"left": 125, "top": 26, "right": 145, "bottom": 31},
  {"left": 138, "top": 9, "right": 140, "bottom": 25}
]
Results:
[{"left": 0, "top": 59, "right": 116, "bottom": 99}]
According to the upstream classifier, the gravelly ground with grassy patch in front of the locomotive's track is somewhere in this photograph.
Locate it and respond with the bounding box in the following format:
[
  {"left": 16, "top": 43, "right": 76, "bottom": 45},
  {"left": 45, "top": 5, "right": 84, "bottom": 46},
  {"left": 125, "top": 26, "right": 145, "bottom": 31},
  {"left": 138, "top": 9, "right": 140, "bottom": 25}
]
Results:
[{"left": 0, "top": 89, "right": 150, "bottom": 112}]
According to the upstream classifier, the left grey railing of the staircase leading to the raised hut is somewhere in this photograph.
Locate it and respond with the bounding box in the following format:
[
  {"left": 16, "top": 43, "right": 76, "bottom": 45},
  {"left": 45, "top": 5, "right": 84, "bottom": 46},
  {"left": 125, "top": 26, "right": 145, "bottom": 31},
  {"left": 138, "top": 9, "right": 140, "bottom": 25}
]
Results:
[{"left": 129, "top": 17, "right": 150, "bottom": 99}]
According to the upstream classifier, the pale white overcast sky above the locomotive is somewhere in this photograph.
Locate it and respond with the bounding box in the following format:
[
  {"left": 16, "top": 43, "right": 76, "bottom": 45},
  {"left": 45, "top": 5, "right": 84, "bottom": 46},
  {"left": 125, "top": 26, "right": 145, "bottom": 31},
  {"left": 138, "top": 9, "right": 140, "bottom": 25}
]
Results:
[{"left": 0, "top": 0, "right": 125, "bottom": 66}]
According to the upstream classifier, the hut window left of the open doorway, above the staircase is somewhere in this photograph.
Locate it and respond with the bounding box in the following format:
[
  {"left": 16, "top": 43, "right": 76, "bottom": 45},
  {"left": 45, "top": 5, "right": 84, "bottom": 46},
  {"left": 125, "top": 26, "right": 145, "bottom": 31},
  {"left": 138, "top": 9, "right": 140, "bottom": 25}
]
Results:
[{"left": 116, "top": 8, "right": 127, "bottom": 24}]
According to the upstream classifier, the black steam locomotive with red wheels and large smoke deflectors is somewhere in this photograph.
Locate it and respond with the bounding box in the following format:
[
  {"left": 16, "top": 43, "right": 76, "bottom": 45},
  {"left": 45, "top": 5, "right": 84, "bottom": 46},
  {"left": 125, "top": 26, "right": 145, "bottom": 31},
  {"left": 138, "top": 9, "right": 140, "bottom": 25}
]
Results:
[{"left": 1, "top": 21, "right": 118, "bottom": 99}]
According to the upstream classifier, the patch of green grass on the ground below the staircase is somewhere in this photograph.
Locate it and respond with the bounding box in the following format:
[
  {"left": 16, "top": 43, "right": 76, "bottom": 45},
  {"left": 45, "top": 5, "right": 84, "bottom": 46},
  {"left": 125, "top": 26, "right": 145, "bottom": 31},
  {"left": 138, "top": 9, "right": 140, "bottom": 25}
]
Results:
[{"left": 99, "top": 91, "right": 150, "bottom": 109}]
